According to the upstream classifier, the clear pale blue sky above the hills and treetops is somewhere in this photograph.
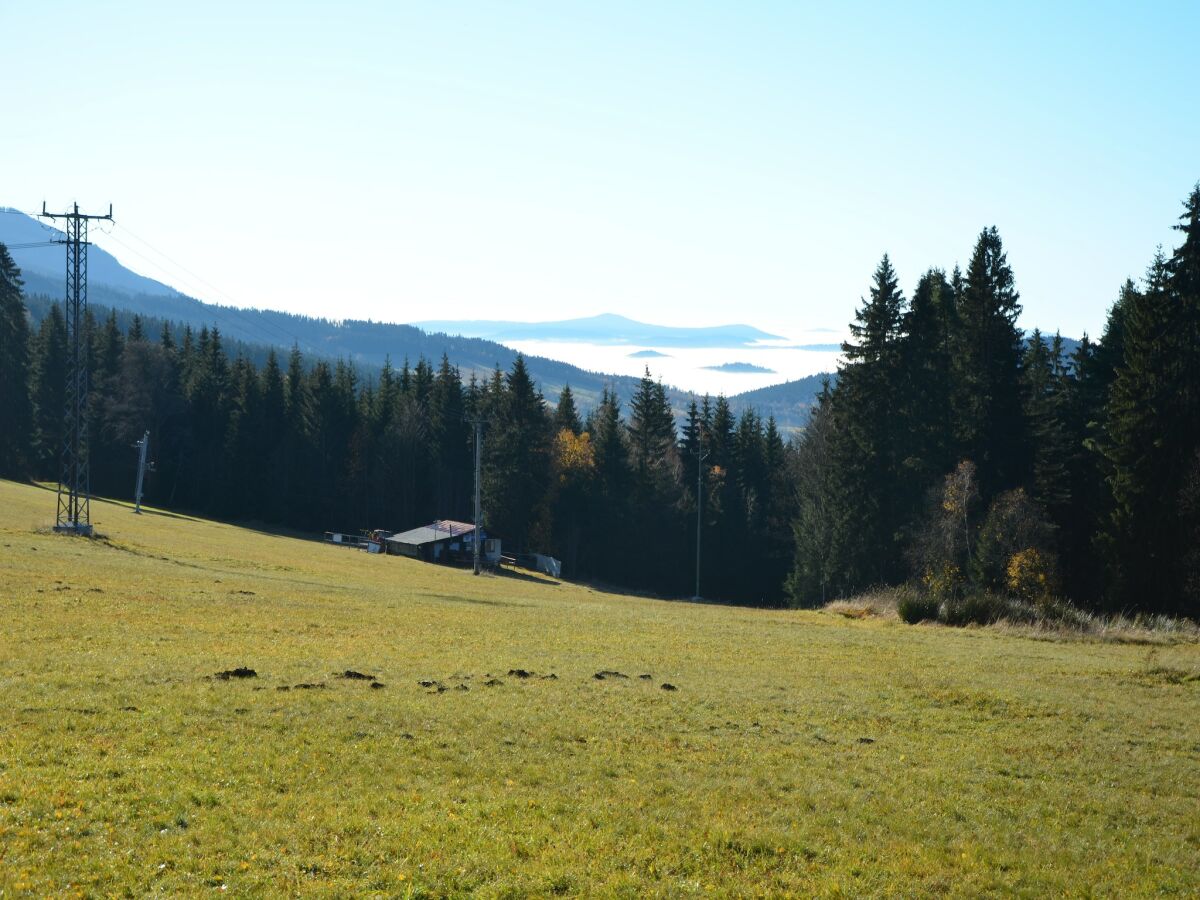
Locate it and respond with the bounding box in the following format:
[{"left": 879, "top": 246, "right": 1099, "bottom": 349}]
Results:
[{"left": 0, "top": 0, "right": 1200, "bottom": 336}]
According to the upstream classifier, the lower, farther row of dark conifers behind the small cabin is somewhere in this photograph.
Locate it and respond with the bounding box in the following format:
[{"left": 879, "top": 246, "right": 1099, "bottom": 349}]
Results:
[{"left": 0, "top": 245, "right": 794, "bottom": 605}]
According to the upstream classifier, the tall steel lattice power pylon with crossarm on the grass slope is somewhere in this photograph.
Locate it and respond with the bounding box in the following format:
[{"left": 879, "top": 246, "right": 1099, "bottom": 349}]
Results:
[{"left": 42, "top": 202, "right": 113, "bottom": 536}]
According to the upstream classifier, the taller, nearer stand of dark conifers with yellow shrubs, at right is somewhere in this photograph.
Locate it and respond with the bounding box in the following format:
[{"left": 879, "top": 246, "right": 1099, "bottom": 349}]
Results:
[{"left": 788, "top": 187, "right": 1200, "bottom": 619}]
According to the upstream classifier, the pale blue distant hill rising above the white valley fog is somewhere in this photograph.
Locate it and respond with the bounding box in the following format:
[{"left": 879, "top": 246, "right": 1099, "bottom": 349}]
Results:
[{"left": 413, "top": 313, "right": 782, "bottom": 348}]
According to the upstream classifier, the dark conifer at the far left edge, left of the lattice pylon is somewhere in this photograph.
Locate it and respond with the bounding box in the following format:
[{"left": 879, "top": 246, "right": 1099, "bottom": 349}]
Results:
[{"left": 0, "top": 244, "right": 34, "bottom": 478}]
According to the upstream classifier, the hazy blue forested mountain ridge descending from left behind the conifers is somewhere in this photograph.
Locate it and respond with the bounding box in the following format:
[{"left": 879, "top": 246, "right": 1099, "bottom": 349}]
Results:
[{"left": 0, "top": 210, "right": 825, "bottom": 430}]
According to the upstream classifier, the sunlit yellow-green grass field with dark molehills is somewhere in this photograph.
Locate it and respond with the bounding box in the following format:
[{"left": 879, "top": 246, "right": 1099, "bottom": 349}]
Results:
[{"left": 0, "top": 481, "right": 1200, "bottom": 898}]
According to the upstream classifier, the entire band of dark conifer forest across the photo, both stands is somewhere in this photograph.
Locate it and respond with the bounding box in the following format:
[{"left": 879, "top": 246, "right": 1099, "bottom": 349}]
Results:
[{"left": 0, "top": 186, "right": 1200, "bottom": 622}]
